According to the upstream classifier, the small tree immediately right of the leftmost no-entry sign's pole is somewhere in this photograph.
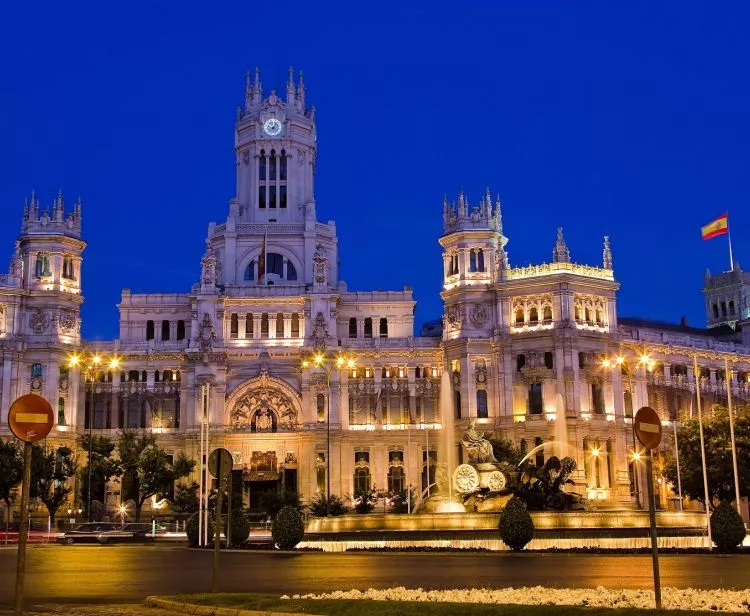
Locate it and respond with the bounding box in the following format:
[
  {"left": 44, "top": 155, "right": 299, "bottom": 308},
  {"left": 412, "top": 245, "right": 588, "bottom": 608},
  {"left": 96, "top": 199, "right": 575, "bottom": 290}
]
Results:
[{"left": 31, "top": 445, "right": 77, "bottom": 524}]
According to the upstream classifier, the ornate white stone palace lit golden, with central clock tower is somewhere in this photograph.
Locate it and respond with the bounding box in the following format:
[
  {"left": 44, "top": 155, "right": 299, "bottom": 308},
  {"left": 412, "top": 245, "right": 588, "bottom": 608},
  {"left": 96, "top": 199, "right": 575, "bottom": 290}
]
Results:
[{"left": 0, "top": 71, "right": 750, "bottom": 509}]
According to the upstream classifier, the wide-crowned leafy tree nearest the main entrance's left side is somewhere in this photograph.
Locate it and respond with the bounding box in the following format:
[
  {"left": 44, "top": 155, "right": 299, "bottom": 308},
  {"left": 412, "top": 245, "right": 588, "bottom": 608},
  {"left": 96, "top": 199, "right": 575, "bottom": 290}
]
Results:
[{"left": 117, "top": 431, "right": 195, "bottom": 522}]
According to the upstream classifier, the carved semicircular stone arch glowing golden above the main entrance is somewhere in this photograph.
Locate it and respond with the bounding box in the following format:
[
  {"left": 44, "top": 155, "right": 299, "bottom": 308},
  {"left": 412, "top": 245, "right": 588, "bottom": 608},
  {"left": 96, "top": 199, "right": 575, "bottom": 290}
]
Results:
[{"left": 226, "top": 374, "right": 302, "bottom": 432}]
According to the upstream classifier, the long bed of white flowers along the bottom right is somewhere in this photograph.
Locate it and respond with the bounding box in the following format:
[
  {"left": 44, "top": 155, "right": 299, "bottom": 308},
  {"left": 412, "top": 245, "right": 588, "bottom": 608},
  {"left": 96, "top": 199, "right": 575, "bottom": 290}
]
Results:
[{"left": 281, "top": 586, "right": 750, "bottom": 613}]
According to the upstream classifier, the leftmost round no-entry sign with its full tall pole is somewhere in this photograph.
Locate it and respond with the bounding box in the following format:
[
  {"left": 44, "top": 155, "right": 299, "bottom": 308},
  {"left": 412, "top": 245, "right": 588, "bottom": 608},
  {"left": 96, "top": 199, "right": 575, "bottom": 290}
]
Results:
[{"left": 8, "top": 394, "right": 54, "bottom": 616}]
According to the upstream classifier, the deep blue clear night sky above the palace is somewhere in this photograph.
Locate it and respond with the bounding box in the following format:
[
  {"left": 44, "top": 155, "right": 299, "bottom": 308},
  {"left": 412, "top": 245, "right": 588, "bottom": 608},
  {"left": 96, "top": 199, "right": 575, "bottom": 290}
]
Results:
[{"left": 0, "top": 1, "right": 750, "bottom": 339}]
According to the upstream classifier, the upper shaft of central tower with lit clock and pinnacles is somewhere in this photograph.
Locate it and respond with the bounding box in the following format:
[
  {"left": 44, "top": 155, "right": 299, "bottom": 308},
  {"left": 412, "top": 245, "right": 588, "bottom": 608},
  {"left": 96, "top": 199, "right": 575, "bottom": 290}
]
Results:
[{"left": 233, "top": 68, "right": 316, "bottom": 223}]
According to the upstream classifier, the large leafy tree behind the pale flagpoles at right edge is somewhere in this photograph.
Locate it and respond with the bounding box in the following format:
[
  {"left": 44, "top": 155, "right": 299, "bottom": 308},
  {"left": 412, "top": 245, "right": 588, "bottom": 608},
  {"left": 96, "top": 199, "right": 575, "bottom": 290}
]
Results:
[{"left": 663, "top": 405, "right": 750, "bottom": 509}]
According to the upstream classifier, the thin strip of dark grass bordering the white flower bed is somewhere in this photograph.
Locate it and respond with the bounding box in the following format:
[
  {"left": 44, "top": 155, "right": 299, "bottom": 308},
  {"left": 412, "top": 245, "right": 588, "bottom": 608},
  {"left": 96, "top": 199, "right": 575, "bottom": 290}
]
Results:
[{"left": 156, "top": 593, "right": 732, "bottom": 616}]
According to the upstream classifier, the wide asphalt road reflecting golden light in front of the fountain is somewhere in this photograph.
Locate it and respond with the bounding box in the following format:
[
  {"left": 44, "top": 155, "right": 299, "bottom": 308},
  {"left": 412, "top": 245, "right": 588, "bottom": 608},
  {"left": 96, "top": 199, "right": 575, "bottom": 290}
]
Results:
[{"left": 0, "top": 545, "right": 750, "bottom": 605}]
